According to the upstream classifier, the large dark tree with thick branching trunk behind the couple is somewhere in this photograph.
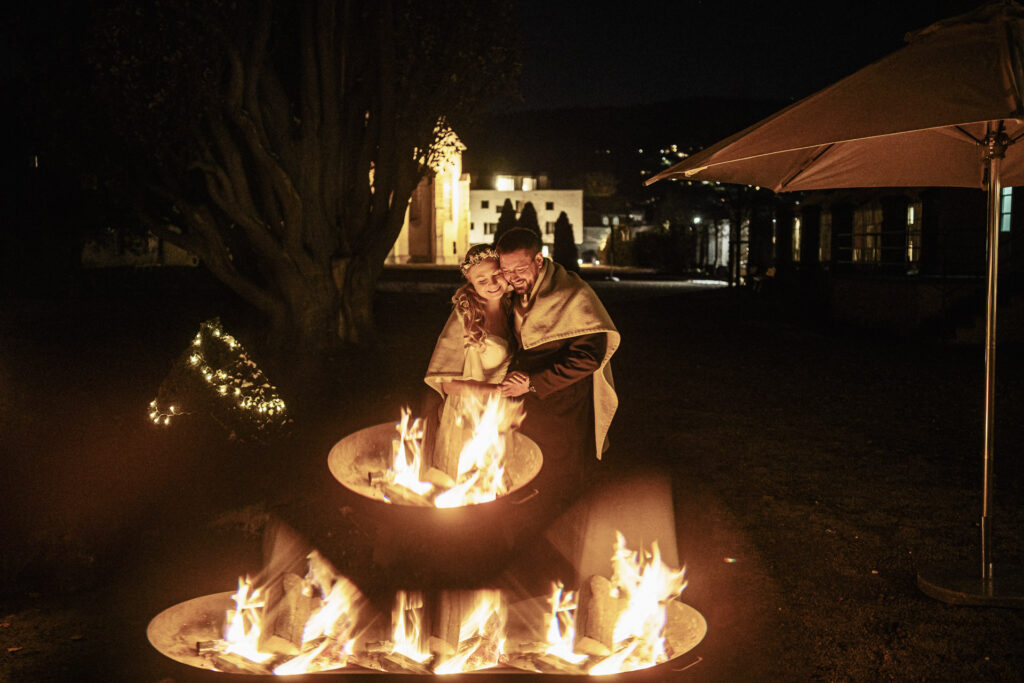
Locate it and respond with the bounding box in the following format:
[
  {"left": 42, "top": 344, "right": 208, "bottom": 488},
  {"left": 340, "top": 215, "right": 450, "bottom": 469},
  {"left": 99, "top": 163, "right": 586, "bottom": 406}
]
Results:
[{"left": 92, "top": 0, "right": 517, "bottom": 352}]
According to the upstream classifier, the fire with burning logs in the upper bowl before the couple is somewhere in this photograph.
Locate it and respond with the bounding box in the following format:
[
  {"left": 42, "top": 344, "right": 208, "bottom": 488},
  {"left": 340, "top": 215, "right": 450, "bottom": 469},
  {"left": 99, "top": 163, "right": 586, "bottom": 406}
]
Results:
[{"left": 371, "top": 394, "right": 523, "bottom": 508}]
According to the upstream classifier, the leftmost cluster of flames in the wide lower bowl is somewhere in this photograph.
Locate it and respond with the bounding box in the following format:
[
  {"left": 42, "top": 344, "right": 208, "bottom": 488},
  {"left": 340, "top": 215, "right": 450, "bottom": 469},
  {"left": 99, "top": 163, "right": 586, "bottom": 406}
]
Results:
[{"left": 214, "top": 551, "right": 361, "bottom": 675}]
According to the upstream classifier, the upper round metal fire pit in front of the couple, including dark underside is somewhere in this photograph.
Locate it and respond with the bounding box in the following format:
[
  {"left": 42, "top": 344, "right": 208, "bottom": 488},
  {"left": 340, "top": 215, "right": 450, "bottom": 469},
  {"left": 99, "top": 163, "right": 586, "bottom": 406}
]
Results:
[{"left": 328, "top": 401, "right": 543, "bottom": 588}]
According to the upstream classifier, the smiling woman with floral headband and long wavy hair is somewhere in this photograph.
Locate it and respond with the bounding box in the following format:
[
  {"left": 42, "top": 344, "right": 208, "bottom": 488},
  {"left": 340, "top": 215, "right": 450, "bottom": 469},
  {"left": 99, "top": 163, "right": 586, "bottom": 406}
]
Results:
[{"left": 424, "top": 245, "right": 514, "bottom": 470}]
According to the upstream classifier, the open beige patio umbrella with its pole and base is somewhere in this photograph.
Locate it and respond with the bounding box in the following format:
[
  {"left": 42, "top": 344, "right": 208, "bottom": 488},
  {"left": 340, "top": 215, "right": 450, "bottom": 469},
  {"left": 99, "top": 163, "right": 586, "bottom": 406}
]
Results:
[{"left": 646, "top": 2, "right": 1024, "bottom": 606}]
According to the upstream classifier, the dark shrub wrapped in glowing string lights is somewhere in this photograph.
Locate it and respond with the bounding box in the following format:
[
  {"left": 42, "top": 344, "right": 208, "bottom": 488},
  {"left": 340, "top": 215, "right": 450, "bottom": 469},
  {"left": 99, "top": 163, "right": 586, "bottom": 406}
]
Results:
[{"left": 150, "top": 318, "right": 292, "bottom": 440}]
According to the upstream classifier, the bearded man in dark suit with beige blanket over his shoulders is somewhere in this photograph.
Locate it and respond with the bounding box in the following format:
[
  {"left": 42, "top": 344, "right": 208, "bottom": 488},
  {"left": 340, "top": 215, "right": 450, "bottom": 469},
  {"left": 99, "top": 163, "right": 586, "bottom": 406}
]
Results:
[{"left": 496, "top": 228, "right": 618, "bottom": 501}]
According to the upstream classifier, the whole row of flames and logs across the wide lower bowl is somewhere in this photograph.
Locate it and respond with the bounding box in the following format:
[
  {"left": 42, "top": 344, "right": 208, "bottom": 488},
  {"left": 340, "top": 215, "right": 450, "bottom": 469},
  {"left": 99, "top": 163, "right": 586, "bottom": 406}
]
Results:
[{"left": 175, "top": 533, "right": 706, "bottom": 676}]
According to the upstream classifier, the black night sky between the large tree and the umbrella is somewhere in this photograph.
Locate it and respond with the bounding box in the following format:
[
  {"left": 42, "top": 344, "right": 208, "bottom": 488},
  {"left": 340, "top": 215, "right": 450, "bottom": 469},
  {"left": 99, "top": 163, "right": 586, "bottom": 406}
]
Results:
[{"left": 521, "top": 0, "right": 984, "bottom": 109}]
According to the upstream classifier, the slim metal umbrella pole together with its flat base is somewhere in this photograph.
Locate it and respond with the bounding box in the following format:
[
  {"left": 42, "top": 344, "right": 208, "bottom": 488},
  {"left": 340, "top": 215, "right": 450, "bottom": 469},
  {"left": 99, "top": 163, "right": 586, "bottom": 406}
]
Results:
[{"left": 918, "top": 122, "right": 1024, "bottom": 607}]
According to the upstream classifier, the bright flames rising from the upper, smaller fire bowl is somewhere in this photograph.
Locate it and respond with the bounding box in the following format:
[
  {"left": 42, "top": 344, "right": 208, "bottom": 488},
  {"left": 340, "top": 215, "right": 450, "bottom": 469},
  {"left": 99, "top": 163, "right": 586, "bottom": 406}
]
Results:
[{"left": 379, "top": 394, "right": 523, "bottom": 508}]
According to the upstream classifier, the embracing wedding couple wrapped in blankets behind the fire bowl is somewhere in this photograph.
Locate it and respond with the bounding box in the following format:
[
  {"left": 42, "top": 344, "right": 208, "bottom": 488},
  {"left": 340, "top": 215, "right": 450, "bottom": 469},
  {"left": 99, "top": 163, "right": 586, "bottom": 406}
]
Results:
[{"left": 425, "top": 228, "right": 620, "bottom": 507}]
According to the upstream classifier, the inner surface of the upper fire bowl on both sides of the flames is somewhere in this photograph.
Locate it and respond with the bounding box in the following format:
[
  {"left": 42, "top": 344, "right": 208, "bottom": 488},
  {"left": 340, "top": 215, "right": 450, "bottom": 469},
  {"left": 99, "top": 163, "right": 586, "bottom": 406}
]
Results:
[{"left": 328, "top": 423, "right": 544, "bottom": 507}]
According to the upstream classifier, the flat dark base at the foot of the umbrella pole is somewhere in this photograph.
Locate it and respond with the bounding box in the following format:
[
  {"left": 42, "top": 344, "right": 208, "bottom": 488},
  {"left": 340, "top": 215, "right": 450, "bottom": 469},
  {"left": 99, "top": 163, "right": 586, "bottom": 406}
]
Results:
[{"left": 918, "top": 564, "right": 1024, "bottom": 608}]
